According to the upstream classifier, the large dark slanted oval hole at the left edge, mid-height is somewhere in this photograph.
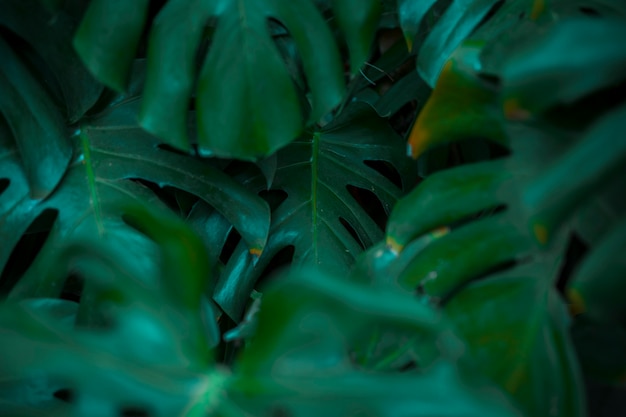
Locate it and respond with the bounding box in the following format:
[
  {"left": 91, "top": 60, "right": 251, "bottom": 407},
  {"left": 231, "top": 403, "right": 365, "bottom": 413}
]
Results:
[{"left": 0, "top": 209, "right": 59, "bottom": 296}]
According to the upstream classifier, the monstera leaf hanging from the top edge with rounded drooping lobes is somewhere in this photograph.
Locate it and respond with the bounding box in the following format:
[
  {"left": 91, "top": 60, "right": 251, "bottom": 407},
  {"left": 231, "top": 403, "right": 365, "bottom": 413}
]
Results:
[{"left": 74, "top": 0, "right": 380, "bottom": 159}]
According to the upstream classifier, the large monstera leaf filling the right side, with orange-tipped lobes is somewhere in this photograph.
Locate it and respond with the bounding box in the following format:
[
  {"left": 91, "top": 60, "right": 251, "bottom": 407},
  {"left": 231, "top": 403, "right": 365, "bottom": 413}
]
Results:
[{"left": 351, "top": 2, "right": 624, "bottom": 415}]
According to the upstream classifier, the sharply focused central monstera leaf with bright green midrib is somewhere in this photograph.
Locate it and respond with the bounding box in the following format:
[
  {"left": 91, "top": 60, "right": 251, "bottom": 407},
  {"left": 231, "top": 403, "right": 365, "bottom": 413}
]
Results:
[{"left": 215, "top": 103, "right": 413, "bottom": 320}]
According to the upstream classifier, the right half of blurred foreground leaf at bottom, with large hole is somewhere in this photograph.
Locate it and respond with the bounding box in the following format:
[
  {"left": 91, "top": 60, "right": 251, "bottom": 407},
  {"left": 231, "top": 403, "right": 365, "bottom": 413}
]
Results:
[{"left": 228, "top": 272, "right": 517, "bottom": 416}]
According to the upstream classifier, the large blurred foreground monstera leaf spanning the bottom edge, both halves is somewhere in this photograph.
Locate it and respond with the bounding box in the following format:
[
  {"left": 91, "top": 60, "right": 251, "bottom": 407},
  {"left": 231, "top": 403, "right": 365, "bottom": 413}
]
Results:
[{"left": 0, "top": 244, "right": 520, "bottom": 417}]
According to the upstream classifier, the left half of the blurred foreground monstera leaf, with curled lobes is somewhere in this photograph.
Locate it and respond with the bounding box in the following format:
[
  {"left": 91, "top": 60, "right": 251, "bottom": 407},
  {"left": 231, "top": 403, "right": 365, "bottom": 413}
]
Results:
[{"left": 0, "top": 208, "right": 225, "bottom": 416}]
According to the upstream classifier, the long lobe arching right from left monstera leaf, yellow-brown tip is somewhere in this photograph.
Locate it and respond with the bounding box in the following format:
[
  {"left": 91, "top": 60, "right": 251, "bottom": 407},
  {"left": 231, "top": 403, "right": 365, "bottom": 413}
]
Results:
[{"left": 81, "top": 100, "right": 269, "bottom": 254}]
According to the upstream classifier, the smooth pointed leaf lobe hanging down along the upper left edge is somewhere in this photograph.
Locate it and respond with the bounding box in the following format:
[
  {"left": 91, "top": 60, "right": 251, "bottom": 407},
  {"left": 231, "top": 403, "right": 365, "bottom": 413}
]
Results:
[{"left": 0, "top": 37, "right": 72, "bottom": 199}]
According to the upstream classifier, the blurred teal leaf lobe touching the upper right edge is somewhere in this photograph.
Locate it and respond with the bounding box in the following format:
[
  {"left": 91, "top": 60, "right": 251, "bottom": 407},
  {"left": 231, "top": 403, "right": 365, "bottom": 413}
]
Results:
[{"left": 502, "top": 18, "right": 626, "bottom": 115}]
